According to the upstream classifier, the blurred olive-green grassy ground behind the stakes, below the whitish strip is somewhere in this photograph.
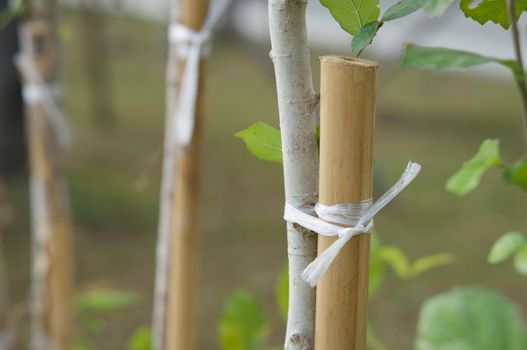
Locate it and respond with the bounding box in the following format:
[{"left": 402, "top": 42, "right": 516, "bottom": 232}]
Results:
[{"left": 2, "top": 10, "right": 527, "bottom": 350}]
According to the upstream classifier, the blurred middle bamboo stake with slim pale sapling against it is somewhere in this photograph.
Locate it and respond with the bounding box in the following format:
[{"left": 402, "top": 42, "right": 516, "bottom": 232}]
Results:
[{"left": 154, "top": 0, "right": 209, "bottom": 350}]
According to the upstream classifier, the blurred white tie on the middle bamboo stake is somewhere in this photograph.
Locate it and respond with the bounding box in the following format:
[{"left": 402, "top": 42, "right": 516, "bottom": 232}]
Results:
[{"left": 168, "top": 0, "right": 230, "bottom": 146}]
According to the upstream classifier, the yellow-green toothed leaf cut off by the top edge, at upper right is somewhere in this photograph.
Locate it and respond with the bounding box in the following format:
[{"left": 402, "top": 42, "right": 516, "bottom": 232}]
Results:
[{"left": 459, "top": 0, "right": 527, "bottom": 29}]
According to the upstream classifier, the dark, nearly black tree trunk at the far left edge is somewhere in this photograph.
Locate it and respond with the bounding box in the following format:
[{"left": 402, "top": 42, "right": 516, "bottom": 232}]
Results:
[{"left": 0, "top": 0, "right": 26, "bottom": 175}]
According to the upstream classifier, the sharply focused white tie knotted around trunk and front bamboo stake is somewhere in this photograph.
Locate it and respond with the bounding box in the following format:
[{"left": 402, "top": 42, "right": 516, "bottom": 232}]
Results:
[{"left": 284, "top": 162, "right": 421, "bottom": 287}]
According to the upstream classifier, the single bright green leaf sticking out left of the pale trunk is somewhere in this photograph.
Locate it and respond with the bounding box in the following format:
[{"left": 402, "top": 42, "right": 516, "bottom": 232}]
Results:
[{"left": 236, "top": 122, "right": 282, "bottom": 163}]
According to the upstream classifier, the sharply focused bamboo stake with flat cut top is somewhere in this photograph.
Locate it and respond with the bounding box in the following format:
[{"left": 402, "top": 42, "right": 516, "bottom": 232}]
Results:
[{"left": 315, "top": 56, "right": 378, "bottom": 350}]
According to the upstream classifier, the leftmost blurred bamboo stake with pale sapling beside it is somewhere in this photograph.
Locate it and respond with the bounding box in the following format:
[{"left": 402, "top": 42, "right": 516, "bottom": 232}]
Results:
[{"left": 17, "top": 6, "right": 73, "bottom": 350}]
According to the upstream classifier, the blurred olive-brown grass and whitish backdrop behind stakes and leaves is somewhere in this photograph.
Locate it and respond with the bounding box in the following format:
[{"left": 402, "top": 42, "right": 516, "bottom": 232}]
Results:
[{"left": 0, "top": 0, "right": 527, "bottom": 350}]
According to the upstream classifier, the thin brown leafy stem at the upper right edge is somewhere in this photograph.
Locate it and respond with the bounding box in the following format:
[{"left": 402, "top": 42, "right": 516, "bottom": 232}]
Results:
[{"left": 506, "top": 0, "right": 527, "bottom": 150}]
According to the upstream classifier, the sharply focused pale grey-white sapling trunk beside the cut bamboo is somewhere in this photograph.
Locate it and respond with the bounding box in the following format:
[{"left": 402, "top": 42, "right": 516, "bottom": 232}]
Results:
[{"left": 269, "top": 0, "right": 318, "bottom": 350}]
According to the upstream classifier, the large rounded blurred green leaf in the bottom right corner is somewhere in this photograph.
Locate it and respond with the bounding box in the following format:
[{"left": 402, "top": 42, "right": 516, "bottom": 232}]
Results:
[{"left": 415, "top": 288, "right": 527, "bottom": 350}]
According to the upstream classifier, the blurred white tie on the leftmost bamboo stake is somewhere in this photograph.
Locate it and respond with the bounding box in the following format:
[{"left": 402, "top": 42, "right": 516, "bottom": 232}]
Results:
[{"left": 15, "top": 54, "right": 72, "bottom": 146}]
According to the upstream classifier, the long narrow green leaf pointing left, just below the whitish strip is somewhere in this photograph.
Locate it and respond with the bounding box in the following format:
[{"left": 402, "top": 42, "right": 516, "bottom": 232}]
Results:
[{"left": 401, "top": 44, "right": 519, "bottom": 75}]
